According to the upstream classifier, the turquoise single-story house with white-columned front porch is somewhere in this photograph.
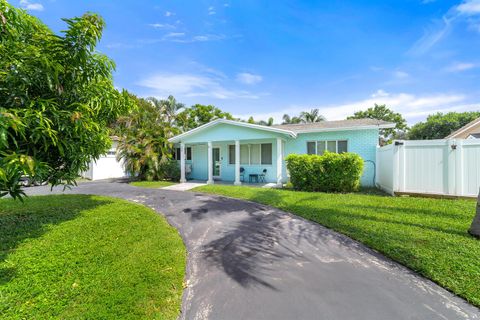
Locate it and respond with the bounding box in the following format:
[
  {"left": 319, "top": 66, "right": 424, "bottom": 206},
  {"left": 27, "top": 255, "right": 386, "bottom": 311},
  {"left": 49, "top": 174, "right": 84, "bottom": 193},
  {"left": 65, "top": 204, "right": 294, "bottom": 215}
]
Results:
[{"left": 169, "top": 119, "right": 395, "bottom": 186}]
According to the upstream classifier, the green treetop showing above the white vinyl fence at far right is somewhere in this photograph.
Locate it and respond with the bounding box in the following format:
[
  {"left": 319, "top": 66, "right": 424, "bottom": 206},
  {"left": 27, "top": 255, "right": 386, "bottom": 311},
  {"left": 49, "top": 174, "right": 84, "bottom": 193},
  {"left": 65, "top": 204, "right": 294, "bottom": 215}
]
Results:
[{"left": 408, "top": 111, "right": 480, "bottom": 140}]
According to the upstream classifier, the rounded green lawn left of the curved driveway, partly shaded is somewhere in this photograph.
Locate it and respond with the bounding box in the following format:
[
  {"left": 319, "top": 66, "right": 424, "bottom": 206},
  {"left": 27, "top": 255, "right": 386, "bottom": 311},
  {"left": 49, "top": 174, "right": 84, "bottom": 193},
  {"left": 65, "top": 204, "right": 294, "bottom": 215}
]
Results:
[{"left": 0, "top": 195, "right": 186, "bottom": 319}]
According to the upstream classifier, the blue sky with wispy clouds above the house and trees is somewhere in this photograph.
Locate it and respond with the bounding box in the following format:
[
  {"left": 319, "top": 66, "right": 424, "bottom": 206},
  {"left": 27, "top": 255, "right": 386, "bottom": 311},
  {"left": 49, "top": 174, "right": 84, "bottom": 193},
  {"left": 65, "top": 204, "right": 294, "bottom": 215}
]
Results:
[{"left": 11, "top": 0, "right": 480, "bottom": 124}]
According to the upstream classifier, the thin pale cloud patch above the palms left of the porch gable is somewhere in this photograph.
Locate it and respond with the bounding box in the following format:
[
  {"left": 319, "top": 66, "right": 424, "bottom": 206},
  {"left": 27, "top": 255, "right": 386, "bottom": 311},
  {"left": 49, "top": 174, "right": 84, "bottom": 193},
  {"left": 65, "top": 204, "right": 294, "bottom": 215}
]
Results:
[{"left": 138, "top": 73, "right": 258, "bottom": 99}]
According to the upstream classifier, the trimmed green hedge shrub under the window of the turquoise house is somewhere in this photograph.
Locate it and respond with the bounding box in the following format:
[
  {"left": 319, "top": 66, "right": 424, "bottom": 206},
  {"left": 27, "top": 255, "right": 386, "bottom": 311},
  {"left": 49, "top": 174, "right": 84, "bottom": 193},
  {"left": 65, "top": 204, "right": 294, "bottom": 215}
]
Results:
[{"left": 285, "top": 152, "right": 363, "bottom": 192}]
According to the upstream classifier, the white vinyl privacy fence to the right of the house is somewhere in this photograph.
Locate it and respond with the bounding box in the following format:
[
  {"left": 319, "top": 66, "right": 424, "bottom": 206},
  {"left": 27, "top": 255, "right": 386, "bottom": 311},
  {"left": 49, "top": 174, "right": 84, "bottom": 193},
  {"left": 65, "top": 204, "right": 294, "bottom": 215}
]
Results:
[{"left": 376, "top": 139, "right": 480, "bottom": 196}]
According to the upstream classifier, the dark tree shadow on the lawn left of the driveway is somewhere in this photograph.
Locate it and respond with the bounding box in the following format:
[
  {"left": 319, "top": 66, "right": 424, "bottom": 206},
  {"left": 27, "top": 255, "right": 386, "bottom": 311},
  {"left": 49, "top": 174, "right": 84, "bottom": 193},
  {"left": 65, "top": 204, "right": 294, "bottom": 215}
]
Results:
[{"left": 0, "top": 195, "right": 109, "bottom": 284}]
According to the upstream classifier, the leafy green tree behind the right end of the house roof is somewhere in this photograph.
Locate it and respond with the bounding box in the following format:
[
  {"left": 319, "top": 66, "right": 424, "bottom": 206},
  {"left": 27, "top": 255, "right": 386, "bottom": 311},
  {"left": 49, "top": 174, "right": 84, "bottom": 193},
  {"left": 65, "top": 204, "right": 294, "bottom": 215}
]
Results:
[{"left": 347, "top": 103, "right": 408, "bottom": 143}]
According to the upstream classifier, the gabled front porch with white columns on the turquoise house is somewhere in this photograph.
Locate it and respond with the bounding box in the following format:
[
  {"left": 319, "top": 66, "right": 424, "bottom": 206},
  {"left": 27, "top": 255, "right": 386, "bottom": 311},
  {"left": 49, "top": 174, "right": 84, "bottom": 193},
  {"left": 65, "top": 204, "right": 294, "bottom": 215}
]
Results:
[{"left": 170, "top": 119, "right": 295, "bottom": 186}]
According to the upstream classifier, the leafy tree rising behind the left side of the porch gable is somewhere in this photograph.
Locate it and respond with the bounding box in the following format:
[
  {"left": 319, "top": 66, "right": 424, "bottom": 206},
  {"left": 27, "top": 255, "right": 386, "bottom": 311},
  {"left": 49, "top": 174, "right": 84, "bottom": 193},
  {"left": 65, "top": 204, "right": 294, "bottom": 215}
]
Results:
[{"left": 176, "top": 104, "right": 234, "bottom": 131}]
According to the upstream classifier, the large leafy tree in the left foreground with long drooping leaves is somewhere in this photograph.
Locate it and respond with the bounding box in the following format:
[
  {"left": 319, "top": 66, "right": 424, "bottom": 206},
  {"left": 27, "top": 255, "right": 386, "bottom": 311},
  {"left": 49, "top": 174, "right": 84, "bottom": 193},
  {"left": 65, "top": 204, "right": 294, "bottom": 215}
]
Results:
[{"left": 0, "top": 0, "right": 130, "bottom": 198}]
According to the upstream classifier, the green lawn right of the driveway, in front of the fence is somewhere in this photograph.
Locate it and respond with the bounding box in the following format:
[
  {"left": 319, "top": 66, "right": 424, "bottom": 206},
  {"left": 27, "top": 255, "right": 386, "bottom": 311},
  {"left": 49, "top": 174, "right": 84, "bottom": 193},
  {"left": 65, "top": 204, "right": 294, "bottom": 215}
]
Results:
[{"left": 194, "top": 185, "right": 480, "bottom": 306}]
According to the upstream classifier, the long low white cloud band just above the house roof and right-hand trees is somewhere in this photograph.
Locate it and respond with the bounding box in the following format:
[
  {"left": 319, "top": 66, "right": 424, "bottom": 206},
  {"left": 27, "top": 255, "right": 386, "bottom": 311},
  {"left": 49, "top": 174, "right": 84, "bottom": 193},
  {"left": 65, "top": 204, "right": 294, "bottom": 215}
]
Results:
[{"left": 235, "top": 90, "right": 470, "bottom": 124}]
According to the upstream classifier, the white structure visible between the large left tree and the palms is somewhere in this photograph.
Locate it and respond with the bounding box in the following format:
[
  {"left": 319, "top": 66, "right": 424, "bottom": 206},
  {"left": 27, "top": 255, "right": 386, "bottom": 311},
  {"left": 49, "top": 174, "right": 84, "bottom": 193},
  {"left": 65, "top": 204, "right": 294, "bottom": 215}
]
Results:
[{"left": 80, "top": 137, "right": 127, "bottom": 180}]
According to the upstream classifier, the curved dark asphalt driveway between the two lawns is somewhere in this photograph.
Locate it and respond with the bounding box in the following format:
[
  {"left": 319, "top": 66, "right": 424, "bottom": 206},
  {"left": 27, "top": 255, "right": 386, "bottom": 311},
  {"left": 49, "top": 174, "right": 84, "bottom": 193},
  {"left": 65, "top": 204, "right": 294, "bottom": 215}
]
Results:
[{"left": 27, "top": 182, "right": 480, "bottom": 320}]
